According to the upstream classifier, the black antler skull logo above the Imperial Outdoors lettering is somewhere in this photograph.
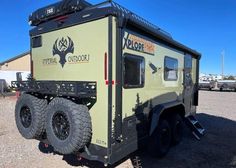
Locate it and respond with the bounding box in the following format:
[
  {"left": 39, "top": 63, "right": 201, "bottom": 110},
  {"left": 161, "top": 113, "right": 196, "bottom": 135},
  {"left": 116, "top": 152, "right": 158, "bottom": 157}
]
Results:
[{"left": 52, "top": 36, "right": 74, "bottom": 68}]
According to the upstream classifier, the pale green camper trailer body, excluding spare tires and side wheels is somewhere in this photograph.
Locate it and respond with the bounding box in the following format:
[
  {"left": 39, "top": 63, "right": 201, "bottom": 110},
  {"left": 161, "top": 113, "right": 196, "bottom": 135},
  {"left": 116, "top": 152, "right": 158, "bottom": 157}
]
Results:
[{"left": 13, "top": 2, "right": 200, "bottom": 164}]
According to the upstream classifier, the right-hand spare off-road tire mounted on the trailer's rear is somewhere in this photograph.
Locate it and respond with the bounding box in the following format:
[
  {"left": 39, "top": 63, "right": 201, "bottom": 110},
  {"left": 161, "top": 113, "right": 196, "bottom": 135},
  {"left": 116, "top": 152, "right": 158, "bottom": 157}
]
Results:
[{"left": 46, "top": 98, "right": 92, "bottom": 154}]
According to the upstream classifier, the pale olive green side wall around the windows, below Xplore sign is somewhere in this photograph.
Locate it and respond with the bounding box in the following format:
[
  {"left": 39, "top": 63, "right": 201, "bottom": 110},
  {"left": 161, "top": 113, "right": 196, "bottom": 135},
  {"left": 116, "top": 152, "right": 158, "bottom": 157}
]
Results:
[{"left": 123, "top": 31, "right": 184, "bottom": 118}]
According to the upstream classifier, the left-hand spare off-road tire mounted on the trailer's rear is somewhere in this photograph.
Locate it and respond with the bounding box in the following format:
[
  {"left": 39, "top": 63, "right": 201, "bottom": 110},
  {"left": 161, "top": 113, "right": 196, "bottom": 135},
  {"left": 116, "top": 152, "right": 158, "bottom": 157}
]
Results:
[{"left": 15, "top": 94, "right": 47, "bottom": 139}]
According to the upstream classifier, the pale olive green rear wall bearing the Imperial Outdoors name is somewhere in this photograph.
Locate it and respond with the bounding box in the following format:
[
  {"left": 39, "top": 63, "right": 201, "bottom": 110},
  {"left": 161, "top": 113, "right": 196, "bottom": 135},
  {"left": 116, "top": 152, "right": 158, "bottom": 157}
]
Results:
[{"left": 31, "top": 18, "right": 109, "bottom": 148}]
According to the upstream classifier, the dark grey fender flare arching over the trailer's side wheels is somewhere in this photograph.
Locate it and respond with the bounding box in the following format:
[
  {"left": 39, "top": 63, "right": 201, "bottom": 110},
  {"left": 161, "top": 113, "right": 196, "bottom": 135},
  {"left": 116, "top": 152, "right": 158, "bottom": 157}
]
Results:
[{"left": 149, "top": 101, "right": 185, "bottom": 135}]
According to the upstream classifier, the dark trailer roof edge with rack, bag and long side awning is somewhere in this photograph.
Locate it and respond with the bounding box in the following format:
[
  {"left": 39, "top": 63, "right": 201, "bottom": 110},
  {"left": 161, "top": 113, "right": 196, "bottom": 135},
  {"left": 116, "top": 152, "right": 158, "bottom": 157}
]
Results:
[{"left": 29, "top": 0, "right": 201, "bottom": 59}]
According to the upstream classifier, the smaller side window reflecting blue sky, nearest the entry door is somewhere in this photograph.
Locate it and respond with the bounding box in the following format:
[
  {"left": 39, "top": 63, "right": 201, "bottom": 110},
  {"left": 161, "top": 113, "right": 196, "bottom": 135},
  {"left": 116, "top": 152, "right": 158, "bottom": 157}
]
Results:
[{"left": 164, "top": 57, "right": 178, "bottom": 81}]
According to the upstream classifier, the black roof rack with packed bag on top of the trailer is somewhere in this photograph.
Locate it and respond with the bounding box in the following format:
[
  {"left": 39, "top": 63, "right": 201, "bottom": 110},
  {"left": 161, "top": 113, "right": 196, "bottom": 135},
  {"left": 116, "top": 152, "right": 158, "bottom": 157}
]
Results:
[{"left": 29, "top": 0, "right": 172, "bottom": 38}]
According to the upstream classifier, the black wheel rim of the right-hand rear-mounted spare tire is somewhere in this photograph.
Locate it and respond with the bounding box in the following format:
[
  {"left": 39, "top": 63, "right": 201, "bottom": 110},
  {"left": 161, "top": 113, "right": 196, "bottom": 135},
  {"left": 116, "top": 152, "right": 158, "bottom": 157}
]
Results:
[{"left": 52, "top": 111, "right": 70, "bottom": 140}]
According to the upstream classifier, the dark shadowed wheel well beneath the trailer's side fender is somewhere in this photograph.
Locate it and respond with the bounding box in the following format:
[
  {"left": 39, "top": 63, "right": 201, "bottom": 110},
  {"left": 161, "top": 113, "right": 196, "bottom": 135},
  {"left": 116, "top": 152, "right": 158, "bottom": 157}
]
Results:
[{"left": 159, "top": 105, "right": 185, "bottom": 120}]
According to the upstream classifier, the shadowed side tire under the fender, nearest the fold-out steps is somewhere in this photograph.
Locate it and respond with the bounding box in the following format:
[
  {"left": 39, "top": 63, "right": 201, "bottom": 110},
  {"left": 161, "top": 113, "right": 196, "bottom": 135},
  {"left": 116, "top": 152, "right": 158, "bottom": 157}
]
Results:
[{"left": 169, "top": 114, "right": 184, "bottom": 145}]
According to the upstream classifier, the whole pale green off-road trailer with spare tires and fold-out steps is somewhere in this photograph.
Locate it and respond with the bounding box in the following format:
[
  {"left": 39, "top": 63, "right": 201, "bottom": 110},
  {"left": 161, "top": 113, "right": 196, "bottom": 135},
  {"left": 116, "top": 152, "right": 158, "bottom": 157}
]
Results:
[{"left": 12, "top": 0, "right": 204, "bottom": 164}]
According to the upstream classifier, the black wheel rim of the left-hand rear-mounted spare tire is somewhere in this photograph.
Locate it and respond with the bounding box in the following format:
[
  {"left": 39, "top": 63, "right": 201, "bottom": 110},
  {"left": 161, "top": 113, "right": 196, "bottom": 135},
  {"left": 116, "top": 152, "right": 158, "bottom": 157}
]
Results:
[{"left": 20, "top": 106, "right": 32, "bottom": 128}]
